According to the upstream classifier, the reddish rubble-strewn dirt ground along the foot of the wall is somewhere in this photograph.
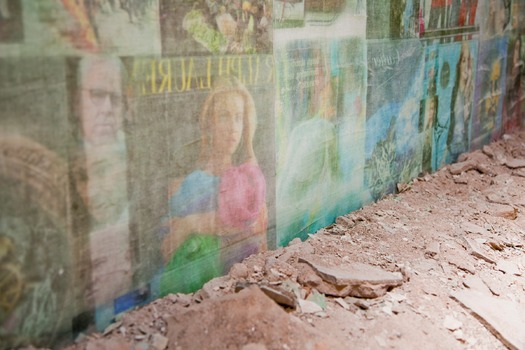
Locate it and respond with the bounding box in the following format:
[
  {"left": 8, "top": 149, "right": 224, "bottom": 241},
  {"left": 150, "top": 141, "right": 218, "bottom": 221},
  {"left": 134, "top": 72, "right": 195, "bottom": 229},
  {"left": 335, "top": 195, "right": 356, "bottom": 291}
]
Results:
[{"left": 34, "top": 130, "right": 525, "bottom": 350}]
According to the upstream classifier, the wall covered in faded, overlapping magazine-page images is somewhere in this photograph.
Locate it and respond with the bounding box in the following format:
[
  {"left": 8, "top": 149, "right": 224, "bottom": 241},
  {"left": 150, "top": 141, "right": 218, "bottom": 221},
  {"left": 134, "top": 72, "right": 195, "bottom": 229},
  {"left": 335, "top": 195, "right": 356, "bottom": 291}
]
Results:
[{"left": 0, "top": 0, "right": 525, "bottom": 348}]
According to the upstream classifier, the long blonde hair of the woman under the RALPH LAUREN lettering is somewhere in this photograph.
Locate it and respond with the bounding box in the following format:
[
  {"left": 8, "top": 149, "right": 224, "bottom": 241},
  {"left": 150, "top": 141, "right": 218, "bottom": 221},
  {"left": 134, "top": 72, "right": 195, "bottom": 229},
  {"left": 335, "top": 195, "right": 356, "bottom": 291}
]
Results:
[{"left": 199, "top": 76, "right": 257, "bottom": 165}]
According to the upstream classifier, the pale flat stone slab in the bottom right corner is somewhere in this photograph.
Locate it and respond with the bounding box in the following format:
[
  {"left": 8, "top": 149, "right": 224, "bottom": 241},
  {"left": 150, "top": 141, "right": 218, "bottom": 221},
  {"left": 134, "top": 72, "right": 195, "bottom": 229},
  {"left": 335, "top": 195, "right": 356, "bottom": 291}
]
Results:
[{"left": 451, "top": 291, "right": 525, "bottom": 350}]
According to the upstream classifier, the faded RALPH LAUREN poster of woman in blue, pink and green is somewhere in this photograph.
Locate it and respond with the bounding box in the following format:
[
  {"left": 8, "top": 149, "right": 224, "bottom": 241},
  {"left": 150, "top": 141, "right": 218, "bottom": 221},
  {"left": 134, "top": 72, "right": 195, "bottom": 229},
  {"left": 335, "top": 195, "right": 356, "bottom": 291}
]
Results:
[{"left": 127, "top": 55, "right": 275, "bottom": 296}]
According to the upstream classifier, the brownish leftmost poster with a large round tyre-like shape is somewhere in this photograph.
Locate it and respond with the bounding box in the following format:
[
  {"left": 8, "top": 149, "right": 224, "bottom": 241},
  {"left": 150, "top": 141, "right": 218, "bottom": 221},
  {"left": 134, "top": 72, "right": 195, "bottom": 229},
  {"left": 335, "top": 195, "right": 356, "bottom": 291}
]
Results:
[{"left": 0, "top": 58, "right": 74, "bottom": 348}]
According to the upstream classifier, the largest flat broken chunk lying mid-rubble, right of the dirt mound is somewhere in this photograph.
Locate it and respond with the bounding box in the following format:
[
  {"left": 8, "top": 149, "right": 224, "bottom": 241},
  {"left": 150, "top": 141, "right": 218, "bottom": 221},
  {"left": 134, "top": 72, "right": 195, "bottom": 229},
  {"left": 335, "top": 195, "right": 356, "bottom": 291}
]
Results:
[{"left": 299, "top": 257, "right": 403, "bottom": 298}]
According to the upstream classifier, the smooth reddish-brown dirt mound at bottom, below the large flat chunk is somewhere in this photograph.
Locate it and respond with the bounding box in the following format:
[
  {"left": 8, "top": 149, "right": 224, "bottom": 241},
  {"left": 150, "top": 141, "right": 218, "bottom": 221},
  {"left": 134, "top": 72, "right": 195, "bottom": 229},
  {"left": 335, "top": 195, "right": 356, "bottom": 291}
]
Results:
[{"left": 167, "top": 285, "right": 341, "bottom": 349}]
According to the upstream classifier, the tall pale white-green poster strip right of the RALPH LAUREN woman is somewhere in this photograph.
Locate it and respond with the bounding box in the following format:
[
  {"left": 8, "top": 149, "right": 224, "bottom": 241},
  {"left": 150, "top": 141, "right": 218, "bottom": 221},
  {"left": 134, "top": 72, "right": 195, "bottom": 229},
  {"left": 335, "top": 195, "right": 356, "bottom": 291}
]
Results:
[{"left": 274, "top": 1, "right": 369, "bottom": 245}]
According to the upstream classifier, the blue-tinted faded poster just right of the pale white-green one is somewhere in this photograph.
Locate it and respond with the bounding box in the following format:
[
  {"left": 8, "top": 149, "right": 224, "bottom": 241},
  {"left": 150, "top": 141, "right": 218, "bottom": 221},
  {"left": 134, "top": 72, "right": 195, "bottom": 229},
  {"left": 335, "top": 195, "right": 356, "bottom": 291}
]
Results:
[{"left": 365, "top": 40, "right": 423, "bottom": 200}]
